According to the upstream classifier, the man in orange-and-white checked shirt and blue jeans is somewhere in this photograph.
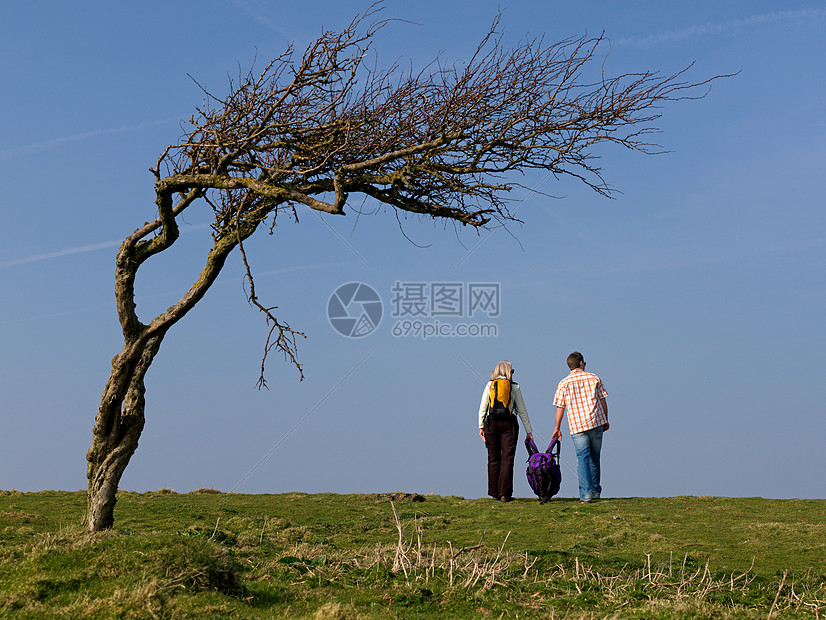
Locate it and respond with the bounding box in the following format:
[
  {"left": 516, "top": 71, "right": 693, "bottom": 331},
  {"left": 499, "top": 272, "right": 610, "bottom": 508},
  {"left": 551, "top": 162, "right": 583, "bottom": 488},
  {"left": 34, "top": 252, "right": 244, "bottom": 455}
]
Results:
[{"left": 551, "top": 351, "right": 609, "bottom": 503}]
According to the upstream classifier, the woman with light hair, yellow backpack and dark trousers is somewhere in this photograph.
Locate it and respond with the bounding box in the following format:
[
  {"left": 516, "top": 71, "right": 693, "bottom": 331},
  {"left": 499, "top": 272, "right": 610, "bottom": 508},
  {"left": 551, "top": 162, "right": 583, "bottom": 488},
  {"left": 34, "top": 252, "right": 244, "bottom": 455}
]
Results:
[{"left": 479, "top": 360, "right": 533, "bottom": 502}]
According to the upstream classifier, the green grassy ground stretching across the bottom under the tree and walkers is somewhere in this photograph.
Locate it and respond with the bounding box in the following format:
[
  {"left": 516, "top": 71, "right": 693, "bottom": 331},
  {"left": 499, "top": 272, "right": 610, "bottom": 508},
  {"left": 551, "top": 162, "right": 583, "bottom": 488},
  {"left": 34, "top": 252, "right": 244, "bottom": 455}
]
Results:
[{"left": 0, "top": 490, "right": 826, "bottom": 619}]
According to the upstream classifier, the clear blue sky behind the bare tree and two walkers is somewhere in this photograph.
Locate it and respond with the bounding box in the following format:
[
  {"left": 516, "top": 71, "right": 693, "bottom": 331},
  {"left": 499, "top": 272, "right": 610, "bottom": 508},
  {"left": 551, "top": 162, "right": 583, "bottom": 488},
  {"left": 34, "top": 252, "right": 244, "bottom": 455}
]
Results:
[{"left": 0, "top": 0, "right": 826, "bottom": 498}]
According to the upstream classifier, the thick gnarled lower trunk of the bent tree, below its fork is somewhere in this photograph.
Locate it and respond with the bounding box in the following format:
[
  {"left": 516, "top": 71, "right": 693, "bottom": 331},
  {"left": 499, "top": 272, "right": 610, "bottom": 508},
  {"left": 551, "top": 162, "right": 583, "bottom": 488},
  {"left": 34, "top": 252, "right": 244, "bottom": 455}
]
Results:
[{"left": 86, "top": 334, "right": 163, "bottom": 532}]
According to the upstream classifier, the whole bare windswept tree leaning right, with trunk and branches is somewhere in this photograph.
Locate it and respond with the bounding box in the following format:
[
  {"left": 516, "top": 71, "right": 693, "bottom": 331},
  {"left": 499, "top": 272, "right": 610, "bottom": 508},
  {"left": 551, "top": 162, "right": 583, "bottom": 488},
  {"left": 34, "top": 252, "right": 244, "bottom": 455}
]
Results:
[{"left": 86, "top": 10, "right": 707, "bottom": 531}]
